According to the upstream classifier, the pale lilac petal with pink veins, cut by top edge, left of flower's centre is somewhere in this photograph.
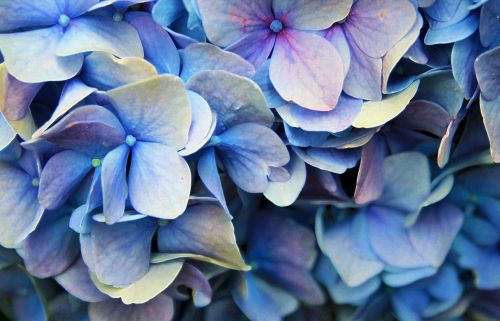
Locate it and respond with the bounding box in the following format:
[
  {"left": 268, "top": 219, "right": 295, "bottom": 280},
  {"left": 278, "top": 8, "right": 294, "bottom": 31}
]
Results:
[{"left": 198, "top": 0, "right": 274, "bottom": 47}]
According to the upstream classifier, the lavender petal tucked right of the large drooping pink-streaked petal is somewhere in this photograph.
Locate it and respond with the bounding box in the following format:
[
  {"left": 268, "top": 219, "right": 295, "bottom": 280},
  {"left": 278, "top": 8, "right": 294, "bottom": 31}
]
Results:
[{"left": 344, "top": 42, "right": 382, "bottom": 100}]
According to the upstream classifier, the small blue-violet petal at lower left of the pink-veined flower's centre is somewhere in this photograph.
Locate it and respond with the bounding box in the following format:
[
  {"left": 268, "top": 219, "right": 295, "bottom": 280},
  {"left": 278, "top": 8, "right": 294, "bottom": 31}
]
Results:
[{"left": 226, "top": 28, "right": 276, "bottom": 68}]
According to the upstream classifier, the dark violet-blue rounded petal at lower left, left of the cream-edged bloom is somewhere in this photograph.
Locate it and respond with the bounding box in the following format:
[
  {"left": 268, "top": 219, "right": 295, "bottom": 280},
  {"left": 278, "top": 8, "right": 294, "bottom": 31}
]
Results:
[{"left": 23, "top": 212, "right": 79, "bottom": 278}]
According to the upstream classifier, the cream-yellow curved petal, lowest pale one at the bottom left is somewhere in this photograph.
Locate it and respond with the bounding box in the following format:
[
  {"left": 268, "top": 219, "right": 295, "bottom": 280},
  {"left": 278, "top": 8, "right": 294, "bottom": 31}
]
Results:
[{"left": 93, "top": 260, "right": 184, "bottom": 304}]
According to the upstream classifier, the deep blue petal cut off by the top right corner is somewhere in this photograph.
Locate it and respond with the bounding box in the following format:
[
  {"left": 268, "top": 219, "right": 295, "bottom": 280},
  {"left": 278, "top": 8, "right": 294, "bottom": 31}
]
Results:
[{"left": 479, "top": 1, "right": 500, "bottom": 48}]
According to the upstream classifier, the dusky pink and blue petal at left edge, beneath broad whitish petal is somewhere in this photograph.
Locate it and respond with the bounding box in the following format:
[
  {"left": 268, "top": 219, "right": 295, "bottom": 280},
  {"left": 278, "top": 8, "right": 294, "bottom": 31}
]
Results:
[{"left": 0, "top": 73, "right": 43, "bottom": 120}]
